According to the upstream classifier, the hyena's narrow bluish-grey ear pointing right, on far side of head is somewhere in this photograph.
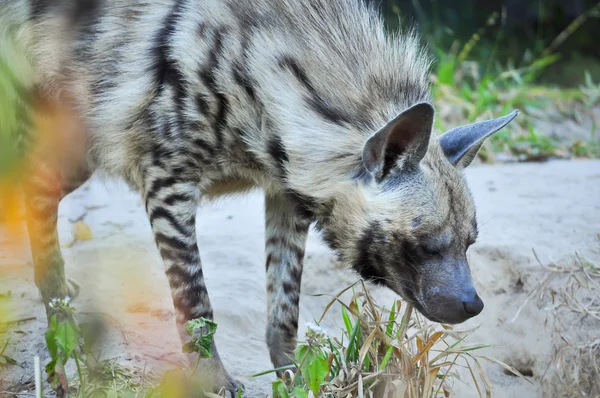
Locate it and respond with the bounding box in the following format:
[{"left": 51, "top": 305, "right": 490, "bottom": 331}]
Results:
[{"left": 439, "top": 110, "right": 519, "bottom": 168}]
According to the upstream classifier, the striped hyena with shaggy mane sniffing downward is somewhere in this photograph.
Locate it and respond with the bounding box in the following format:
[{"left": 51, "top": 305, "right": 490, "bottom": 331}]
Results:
[{"left": 0, "top": 0, "right": 517, "bottom": 390}]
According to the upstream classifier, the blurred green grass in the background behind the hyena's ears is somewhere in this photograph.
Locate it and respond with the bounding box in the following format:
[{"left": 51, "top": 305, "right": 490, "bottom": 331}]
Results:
[{"left": 433, "top": 48, "right": 600, "bottom": 161}]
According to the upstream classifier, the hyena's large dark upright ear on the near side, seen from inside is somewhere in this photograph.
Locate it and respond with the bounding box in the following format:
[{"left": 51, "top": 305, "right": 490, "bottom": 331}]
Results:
[{"left": 362, "top": 102, "right": 435, "bottom": 175}]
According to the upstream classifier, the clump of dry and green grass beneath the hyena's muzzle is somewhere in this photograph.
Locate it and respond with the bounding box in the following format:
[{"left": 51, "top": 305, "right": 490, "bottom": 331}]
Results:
[{"left": 264, "top": 282, "right": 523, "bottom": 398}]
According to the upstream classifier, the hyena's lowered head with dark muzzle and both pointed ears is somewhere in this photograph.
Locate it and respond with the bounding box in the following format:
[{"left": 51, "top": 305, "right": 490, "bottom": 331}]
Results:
[{"left": 325, "top": 103, "right": 518, "bottom": 324}]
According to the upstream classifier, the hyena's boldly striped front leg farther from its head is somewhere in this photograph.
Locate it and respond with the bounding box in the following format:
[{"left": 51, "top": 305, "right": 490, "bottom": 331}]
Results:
[{"left": 144, "top": 172, "right": 241, "bottom": 396}]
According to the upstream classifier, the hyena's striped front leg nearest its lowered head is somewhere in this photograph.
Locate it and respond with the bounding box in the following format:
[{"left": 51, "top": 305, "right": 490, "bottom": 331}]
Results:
[{"left": 265, "top": 195, "right": 310, "bottom": 368}]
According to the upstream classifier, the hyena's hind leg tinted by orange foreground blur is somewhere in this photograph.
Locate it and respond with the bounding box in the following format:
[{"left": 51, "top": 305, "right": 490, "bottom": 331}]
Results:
[{"left": 22, "top": 159, "right": 91, "bottom": 320}]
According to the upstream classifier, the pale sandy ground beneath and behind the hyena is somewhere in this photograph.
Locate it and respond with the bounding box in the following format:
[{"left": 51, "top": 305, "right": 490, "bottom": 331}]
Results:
[{"left": 0, "top": 161, "right": 600, "bottom": 397}]
